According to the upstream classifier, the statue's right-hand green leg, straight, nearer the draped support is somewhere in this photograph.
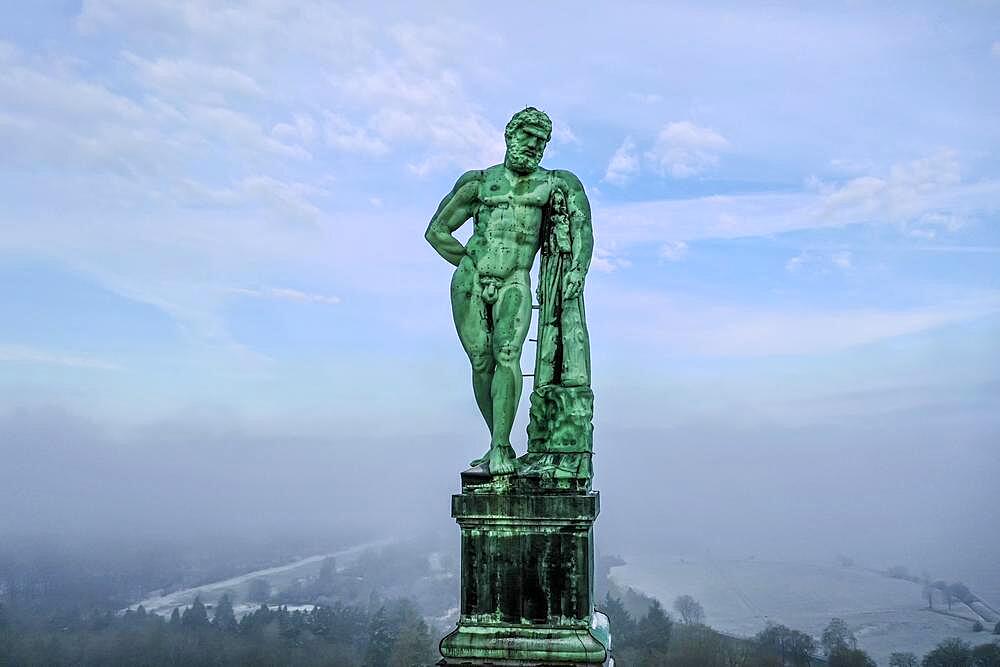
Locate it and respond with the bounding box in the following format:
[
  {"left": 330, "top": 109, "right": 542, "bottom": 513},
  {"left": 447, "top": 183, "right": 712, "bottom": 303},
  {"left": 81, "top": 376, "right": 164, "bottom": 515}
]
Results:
[{"left": 490, "top": 281, "right": 531, "bottom": 475}]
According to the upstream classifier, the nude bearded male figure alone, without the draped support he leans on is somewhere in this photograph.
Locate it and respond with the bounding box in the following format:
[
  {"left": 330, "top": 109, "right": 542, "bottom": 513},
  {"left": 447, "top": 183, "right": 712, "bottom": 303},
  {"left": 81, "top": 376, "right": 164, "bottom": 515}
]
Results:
[{"left": 425, "top": 107, "right": 593, "bottom": 475}]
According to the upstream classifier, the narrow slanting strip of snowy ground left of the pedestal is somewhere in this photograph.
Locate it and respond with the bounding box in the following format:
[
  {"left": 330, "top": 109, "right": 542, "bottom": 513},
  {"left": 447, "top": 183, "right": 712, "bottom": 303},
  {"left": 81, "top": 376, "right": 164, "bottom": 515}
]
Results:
[{"left": 129, "top": 540, "right": 389, "bottom": 616}]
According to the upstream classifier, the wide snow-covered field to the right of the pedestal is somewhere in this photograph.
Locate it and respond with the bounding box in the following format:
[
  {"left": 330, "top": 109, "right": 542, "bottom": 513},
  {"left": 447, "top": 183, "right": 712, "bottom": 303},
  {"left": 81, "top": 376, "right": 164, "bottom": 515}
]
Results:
[{"left": 612, "top": 557, "right": 997, "bottom": 665}]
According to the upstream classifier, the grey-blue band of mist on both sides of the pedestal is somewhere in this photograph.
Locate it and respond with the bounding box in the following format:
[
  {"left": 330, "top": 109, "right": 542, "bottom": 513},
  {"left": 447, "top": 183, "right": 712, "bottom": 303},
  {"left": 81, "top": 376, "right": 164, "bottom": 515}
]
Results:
[{"left": 0, "top": 386, "right": 1000, "bottom": 602}]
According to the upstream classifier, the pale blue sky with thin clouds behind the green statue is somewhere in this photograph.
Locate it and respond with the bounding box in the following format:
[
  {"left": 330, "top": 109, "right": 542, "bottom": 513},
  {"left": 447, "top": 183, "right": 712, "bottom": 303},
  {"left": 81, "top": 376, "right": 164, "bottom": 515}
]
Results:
[{"left": 0, "top": 0, "right": 1000, "bottom": 588}]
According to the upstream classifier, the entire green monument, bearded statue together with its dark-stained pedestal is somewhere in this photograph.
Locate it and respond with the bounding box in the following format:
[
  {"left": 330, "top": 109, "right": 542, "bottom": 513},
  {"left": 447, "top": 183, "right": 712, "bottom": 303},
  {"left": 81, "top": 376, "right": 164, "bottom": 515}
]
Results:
[{"left": 426, "top": 107, "right": 610, "bottom": 667}]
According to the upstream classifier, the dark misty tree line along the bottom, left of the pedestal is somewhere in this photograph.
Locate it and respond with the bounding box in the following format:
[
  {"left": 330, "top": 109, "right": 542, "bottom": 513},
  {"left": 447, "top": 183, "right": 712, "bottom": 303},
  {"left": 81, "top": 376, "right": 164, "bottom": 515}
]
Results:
[{"left": 0, "top": 596, "right": 436, "bottom": 667}]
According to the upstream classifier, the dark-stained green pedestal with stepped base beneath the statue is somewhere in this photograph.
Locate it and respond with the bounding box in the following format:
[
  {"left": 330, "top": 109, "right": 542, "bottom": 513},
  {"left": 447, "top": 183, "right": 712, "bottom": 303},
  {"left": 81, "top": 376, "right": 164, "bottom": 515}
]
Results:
[{"left": 438, "top": 469, "right": 609, "bottom": 667}]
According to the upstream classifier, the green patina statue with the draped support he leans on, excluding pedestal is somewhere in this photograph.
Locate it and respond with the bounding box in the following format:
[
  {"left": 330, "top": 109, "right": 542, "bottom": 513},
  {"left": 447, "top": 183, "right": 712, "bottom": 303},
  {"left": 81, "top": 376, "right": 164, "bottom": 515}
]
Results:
[{"left": 425, "top": 107, "right": 594, "bottom": 487}]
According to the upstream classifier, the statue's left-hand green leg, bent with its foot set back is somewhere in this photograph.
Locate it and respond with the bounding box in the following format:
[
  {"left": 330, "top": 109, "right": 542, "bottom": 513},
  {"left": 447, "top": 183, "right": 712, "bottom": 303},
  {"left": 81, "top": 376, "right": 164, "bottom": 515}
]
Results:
[{"left": 451, "top": 261, "right": 496, "bottom": 466}]
